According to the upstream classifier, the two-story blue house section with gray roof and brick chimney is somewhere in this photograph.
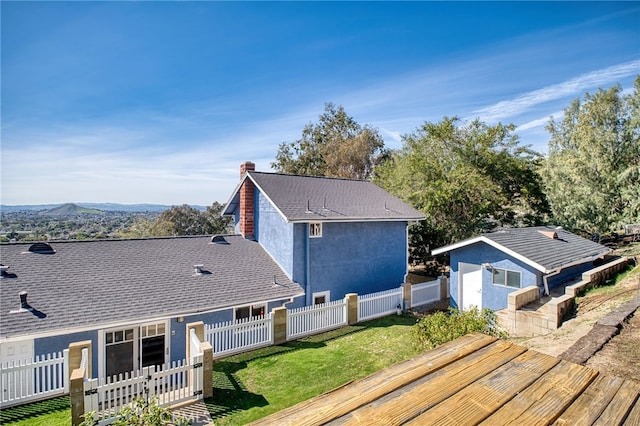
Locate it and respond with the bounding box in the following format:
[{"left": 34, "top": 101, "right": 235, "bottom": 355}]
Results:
[{"left": 223, "top": 162, "right": 424, "bottom": 305}]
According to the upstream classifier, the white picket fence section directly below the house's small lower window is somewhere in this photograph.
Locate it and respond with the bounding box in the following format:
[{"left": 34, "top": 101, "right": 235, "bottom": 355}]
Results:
[{"left": 287, "top": 300, "right": 347, "bottom": 340}]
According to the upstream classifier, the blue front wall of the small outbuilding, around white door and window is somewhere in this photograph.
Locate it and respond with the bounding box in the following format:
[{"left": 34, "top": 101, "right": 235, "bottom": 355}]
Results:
[{"left": 449, "top": 242, "right": 544, "bottom": 310}]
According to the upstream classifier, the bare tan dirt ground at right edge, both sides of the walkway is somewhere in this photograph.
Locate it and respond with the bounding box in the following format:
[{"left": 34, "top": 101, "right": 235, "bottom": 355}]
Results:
[{"left": 512, "top": 267, "right": 640, "bottom": 370}]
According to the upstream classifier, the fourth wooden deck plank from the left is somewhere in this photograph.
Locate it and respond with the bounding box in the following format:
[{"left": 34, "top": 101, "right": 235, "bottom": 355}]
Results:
[{"left": 483, "top": 361, "right": 598, "bottom": 425}]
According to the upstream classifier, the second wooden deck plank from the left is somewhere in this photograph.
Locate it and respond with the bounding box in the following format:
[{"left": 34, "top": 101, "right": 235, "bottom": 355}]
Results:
[{"left": 329, "top": 341, "right": 526, "bottom": 426}]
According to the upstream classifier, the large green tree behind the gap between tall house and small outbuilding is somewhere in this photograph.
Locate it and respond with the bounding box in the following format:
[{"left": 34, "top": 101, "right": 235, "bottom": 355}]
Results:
[{"left": 374, "top": 117, "right": 549, "bottom": 263}]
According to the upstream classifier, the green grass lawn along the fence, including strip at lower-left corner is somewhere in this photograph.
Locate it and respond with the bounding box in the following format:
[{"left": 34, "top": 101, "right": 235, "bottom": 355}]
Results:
[{"left": 0, "top": 315, "right": 419, "bottom": 426}]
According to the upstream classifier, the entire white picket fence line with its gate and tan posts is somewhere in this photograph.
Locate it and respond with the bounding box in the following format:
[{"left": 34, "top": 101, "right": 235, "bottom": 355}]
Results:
[{"left": 0, "top": 276, "right": 449, "bottom": 425}]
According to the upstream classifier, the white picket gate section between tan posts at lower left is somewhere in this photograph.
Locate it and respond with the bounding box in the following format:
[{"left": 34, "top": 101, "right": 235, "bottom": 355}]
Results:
[{"left": 84, "top": 354, "right": 204, "bottom": 424}]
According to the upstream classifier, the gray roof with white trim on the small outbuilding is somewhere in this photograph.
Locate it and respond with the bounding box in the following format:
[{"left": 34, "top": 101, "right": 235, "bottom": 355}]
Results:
[{"left": 432, "top": 226, "right": 611, "bottom": 272}]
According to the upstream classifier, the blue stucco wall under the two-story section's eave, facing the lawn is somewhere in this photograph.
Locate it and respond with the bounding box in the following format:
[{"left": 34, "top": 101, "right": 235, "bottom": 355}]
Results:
[{"left": 308, "top": 222, "right": 407, "bottom": 300}]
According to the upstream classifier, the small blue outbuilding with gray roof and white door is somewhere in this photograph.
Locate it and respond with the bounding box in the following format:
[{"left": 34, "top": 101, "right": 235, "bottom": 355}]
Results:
[{"left": 431, "top": 226, "right": 611, "bottom": 311}]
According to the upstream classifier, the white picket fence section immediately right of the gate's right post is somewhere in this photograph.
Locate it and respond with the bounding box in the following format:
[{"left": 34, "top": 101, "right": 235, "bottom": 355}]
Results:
[{"left": 204, "top": 314, "right": 273, "bottom": 358}]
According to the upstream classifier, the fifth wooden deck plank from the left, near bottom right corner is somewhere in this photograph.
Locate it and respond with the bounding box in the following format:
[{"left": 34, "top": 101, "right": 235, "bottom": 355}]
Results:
[{"left": 553, "top": 374, "right": 624, "bottom": 426}]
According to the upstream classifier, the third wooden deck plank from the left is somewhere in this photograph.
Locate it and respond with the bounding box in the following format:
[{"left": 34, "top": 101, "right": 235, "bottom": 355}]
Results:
[{"left": 406, "top": 351, "right": 560, "bottom": 425}]
